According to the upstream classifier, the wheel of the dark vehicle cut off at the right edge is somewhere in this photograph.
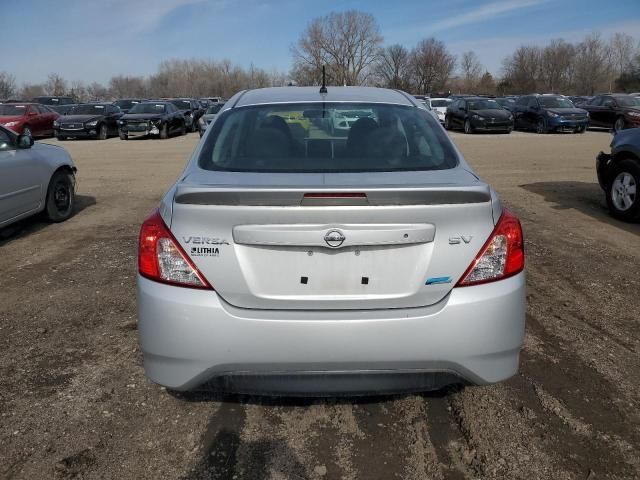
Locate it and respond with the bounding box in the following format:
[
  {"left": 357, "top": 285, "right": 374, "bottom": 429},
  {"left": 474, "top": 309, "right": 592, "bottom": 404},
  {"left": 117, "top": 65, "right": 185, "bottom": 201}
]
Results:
[{"left": 606, "top": 159, "right": 640, "bottom": 222}]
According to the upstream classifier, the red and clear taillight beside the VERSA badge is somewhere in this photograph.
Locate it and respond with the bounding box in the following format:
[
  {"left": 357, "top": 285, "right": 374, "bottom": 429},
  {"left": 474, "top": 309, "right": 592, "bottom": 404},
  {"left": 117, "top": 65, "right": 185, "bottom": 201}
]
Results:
[{"left": 138, "top": 210, "right": 211, "bottom": 288}]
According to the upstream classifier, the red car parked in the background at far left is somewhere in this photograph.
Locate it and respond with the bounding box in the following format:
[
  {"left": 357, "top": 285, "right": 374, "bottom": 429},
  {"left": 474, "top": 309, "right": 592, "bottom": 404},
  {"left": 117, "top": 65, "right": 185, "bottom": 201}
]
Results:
[{"left": 0, "top": 103, "right": 60, "bottom": 137}]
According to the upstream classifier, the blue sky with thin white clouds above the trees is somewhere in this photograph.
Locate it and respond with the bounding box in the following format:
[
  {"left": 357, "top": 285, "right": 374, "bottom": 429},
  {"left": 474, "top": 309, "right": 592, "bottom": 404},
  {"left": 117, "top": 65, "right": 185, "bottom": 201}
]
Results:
[{"left": 0, "top": 0, "right": 640, "bottom": 84}]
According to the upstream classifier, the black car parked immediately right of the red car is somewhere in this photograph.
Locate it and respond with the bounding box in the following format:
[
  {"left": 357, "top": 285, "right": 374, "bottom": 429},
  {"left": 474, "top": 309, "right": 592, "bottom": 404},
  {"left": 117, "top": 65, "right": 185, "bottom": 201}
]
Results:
[{"left": 53, "top": 103, "right": 123, "bottom": 140}]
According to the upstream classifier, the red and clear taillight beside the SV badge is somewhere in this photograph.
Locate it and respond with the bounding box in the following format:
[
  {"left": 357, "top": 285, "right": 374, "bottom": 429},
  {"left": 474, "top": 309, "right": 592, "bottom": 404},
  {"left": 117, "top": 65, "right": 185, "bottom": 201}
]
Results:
[{"left": 456, "top": 208, "right": 524, "bottom": 287}]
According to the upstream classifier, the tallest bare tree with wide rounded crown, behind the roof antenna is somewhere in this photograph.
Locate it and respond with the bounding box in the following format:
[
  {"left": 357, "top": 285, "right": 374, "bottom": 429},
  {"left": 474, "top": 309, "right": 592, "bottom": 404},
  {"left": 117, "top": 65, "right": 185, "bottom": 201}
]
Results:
[{"left": 291, "top": 10, "right": 382, "bottom": 85}]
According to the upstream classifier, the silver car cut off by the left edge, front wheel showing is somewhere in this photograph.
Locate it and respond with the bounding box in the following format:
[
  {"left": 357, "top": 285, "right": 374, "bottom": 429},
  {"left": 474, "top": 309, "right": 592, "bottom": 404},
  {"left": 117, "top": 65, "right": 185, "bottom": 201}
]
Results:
[{"left": 0, "top": 126, "right": 76, "bottom": 227}]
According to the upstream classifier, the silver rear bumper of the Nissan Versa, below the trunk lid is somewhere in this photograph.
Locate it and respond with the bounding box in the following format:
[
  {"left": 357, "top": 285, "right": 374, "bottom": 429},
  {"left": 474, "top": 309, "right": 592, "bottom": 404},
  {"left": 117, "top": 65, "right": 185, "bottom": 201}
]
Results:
[{"left": 138, "top": 273, "right": 525, "bottom": 394}]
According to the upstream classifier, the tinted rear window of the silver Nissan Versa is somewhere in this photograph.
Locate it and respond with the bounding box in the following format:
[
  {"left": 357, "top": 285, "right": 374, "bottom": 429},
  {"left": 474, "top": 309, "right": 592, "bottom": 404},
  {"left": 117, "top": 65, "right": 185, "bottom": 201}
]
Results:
[{"left": 198, "top": 103, "right": 458, "bottom": 173}]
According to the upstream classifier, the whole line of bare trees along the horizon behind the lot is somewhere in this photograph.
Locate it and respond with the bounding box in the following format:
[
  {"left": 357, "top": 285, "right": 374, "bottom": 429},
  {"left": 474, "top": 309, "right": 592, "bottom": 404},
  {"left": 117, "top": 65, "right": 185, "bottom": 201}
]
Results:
[{"left": 0, "top": 10, "right": 640, "bottom": 101}]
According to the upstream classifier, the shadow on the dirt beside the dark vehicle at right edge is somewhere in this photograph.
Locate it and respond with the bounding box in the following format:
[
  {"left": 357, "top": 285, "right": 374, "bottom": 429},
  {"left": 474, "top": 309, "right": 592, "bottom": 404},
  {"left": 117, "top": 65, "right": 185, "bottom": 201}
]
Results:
[{"left": 520, "top": 181, "right": 640, "bottom": 234}]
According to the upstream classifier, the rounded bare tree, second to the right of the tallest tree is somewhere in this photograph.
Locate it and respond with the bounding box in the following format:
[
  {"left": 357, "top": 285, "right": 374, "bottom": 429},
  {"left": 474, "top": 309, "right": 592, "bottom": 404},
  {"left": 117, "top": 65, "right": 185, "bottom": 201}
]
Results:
[{"left": 411, "top": 38, "right": 456, "bottom": 93}]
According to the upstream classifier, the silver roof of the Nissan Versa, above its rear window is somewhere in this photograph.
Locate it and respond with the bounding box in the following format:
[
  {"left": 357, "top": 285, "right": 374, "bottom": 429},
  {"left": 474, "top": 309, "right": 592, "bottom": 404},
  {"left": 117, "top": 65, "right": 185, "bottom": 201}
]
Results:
[{"left": 234, "top": 86, "right": 418, "bottom": 107}]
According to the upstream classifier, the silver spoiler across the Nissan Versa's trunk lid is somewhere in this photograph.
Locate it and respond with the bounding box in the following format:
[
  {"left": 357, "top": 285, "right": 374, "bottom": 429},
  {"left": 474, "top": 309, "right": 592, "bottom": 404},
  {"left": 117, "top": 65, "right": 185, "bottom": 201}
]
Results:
[{"left": 174, "top": 185, "right": 491, "bottom": 207}]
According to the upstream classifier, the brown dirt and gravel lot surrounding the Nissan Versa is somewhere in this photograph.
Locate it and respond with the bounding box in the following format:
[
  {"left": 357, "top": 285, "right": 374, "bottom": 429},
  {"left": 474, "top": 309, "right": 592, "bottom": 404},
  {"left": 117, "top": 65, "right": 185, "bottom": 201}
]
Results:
[{"left": 0, "top": 132, "right": 640, "bottom": 480}]
